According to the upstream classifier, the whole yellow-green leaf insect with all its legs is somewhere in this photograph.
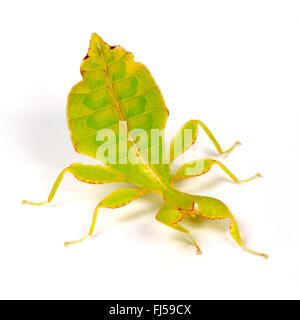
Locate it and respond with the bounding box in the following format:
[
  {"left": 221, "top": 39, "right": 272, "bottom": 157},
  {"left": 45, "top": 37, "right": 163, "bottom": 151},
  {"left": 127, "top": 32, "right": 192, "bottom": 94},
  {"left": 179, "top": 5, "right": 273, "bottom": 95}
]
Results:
[{"left": 23, "top": 34, "right": 267, "bottom": 257}]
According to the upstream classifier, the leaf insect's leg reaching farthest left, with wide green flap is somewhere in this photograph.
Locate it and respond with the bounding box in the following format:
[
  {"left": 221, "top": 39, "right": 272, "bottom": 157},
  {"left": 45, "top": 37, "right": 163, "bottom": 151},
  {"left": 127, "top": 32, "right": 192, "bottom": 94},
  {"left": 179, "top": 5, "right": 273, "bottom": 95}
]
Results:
[{"left": 22, "top": 163, "right": 127, "bottom": 206}]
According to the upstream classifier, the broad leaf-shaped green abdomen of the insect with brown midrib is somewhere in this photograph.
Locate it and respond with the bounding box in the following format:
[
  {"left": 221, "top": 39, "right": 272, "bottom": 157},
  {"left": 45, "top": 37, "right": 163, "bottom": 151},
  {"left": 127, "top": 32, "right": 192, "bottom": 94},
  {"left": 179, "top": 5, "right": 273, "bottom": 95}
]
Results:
[{"left": 67, "top": 34, "right": 170, "bottom": 191}]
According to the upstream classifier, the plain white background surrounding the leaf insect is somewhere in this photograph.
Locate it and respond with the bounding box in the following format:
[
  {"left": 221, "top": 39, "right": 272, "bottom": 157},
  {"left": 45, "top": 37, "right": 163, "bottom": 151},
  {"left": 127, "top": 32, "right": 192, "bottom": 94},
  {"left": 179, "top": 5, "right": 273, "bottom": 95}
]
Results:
[{"left": 0, "top": 0, "right": 300, "bottom": 299}]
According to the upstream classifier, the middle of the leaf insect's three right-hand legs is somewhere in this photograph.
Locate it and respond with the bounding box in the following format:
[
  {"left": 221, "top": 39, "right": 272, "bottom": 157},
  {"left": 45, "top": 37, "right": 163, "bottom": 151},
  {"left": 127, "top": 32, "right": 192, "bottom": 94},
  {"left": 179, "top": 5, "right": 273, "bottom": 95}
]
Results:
[{"left": 173, "top": 159, "right": 261, "bottom": 183}]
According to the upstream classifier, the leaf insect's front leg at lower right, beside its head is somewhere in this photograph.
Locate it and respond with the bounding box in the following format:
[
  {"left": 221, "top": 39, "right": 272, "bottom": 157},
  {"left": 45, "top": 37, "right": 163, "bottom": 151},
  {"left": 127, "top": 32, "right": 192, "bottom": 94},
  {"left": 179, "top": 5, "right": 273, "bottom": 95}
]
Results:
[{"left": 194, "top": 196, "right": 268, "bottom": 259}]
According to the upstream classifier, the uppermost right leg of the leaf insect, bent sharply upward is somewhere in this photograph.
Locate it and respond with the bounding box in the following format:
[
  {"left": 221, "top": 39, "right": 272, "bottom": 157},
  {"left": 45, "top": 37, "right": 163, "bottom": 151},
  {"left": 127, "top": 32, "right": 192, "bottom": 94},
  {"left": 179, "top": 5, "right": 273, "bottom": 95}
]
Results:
[{"left": 170, "top": 120, "right": 241, "bottom": 162}]
